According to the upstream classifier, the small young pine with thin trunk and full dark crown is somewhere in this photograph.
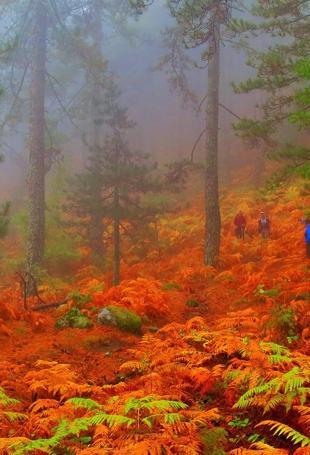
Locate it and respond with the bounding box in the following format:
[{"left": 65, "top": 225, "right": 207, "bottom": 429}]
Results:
[{"left": 67, "top": 90, "right": 161, "bottom": 284}]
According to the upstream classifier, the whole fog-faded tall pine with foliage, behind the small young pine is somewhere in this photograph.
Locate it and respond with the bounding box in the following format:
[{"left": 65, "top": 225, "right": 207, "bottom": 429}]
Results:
[{"left": 60, "top": 0, "right": 145, "bottom": 267}]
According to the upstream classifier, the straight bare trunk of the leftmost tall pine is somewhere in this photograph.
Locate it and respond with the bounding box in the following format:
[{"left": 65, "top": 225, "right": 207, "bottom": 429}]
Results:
[{"left": 27, "top": 0, "right": 47, "bottom": 278}]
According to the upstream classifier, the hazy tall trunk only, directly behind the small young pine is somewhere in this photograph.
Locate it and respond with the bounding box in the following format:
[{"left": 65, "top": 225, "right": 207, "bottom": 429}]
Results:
[{"left": 89, "top": 0, "right": 104, "bottom": 266}]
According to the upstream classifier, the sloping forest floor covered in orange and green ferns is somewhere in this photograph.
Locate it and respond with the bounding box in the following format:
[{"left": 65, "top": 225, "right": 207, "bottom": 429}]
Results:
[{"left": 0, "top": 185, "right": 310, "bottom": 455}]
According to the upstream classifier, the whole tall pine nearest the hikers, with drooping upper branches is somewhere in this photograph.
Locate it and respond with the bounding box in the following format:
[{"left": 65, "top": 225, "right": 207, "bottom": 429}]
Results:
[{"left": 161, "top": 0, "right": 238, "bottom": 265}]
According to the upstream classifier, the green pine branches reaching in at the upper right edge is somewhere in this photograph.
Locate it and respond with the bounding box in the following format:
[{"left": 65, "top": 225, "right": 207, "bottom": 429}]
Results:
[{"left": 232, "top": 0, "right": 310, "bottom": 178}]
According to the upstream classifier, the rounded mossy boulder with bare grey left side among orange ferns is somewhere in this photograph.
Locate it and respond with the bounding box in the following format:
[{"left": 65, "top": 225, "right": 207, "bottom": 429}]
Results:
[{"left": 98, "top": 305, "right": 142, "bottom": 334}]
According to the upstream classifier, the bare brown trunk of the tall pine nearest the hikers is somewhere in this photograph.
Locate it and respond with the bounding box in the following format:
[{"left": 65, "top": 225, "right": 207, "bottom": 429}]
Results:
[{"left": 205, "top": 15, "right": 221, "bottom": 265}]
